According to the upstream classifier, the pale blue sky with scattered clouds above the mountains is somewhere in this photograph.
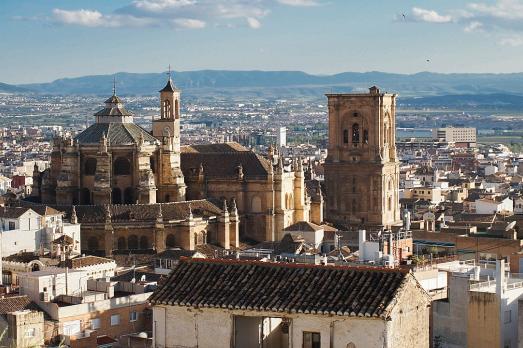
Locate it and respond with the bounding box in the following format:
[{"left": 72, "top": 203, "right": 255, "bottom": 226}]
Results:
[{"left": 0, "top": 0, "right": 523, "bottom": 84}]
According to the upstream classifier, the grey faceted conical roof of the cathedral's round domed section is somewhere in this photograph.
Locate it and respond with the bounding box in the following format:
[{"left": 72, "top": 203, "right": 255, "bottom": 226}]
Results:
[{"left": 75, "top": 123, "right": 159, "bottom": 146}]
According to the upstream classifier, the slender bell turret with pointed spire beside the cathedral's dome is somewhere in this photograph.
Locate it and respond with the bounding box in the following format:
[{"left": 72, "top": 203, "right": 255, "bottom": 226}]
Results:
[{"left": 153, "top": 68, "right": 185, "bottom": 203}]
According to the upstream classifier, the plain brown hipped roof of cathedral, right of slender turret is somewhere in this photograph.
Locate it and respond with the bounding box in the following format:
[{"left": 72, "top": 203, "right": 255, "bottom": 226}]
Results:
[{"left": 181, "top": 143, "right": 271, "bottom": 178}]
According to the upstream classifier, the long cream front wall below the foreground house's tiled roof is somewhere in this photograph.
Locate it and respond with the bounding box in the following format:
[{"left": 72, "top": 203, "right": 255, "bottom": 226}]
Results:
[{"left": 153, "top": 305, "right": 390, "bottom": 348}]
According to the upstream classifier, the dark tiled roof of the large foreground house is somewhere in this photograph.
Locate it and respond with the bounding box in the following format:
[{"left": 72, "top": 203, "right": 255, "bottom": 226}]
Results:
[{"left": 150, "top": 259, "right": 412, "bottom": 318}]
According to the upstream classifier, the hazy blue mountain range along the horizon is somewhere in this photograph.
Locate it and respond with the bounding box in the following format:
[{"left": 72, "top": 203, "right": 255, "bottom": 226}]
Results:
[{"left": 0, "top": 70, "right": 523, "bottom": 104}]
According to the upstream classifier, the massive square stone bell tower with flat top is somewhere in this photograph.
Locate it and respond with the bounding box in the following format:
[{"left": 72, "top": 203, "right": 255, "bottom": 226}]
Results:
[{"left": 325, "top": 86, "right": 401, "bottom": 228}]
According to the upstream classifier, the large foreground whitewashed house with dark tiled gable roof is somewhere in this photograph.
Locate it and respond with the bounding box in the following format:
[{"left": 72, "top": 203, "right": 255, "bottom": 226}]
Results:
[{"left": 150, "top": 259, "right": 430, "bottom": 348}]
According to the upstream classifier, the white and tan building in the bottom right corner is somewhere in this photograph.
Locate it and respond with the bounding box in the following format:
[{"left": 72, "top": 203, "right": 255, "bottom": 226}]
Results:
[{"left": 432, "top": 260, "right": 523, "bottom": 348}]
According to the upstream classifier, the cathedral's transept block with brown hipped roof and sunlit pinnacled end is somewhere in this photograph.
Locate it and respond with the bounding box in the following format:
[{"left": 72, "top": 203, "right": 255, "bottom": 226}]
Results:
[{"left": 182, "top": 143, "right": 311, "bottom": 241}]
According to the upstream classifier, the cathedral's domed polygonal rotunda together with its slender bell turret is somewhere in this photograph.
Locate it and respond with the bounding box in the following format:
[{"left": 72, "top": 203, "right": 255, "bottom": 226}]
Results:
[{"left": 33, "top": 79, "right": 185, "bottom": 205}]
